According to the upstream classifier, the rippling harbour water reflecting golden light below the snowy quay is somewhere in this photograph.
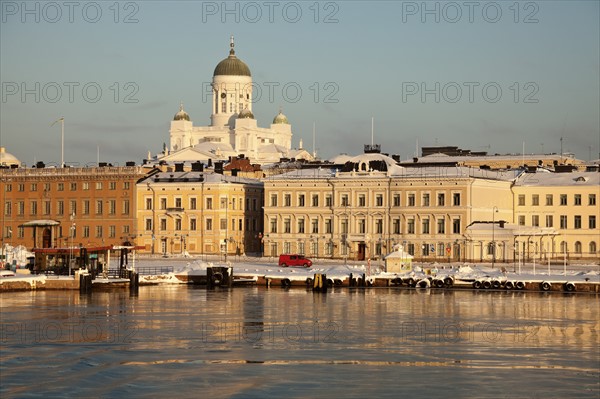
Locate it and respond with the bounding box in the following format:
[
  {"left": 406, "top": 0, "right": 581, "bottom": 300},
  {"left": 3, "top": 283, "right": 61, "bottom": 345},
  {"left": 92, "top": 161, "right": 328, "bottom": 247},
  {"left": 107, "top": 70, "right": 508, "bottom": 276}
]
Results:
[{"left": 0, "top": 287, "right": 600, "bottom": 398}]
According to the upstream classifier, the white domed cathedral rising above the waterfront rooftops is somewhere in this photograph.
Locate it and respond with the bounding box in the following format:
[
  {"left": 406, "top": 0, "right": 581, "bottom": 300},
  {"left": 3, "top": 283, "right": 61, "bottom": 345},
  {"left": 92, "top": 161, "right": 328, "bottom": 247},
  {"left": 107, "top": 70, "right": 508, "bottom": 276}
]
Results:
[{"left": 163, "top": 37, "right": 312, "bottom": 164}]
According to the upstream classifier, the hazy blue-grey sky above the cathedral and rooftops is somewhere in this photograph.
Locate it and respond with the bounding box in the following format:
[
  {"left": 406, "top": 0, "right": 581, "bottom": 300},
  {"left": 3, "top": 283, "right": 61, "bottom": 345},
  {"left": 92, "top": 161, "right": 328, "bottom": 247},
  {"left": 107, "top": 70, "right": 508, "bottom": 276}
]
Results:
[{"left": 0, "top": 0, "right": 600, "bottom": 165}]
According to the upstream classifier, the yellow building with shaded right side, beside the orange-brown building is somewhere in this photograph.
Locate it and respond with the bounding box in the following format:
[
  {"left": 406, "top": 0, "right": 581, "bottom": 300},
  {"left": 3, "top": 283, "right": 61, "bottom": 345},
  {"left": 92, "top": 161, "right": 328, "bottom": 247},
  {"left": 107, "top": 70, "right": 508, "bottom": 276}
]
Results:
[{"left": 136, "top": 168, "right": 263, "bottom": 255}]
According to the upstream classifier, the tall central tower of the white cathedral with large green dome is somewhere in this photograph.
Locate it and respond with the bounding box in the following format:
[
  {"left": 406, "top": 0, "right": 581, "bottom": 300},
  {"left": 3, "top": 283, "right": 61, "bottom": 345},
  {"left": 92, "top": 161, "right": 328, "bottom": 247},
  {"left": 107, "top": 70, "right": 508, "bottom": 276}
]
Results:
[{"left": 210, "top": 36, "right": 252, "bottom": 129}]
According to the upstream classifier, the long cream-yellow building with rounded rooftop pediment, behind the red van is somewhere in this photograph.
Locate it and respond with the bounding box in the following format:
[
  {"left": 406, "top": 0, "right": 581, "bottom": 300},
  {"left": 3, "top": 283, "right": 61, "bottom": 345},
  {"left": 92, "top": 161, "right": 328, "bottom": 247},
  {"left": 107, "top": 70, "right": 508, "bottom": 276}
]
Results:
[{"left": 263, "top": 153, "right": 516, "bottom": 261}]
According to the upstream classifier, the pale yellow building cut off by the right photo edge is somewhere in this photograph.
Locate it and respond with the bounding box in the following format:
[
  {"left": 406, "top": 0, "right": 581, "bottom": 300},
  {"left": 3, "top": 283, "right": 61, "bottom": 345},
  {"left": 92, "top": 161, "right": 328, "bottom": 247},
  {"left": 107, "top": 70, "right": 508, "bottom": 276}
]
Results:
[{"left": 512, "top": 170, "right": 600, "bottom": 261}]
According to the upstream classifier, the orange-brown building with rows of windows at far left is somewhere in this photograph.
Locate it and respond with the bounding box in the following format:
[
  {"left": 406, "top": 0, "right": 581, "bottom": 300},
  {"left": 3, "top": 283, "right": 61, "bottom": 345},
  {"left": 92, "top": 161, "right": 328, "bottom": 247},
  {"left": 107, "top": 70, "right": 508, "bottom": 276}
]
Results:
[{"left": 0, "top": 163, "right": 148, "bottom": 253}]
